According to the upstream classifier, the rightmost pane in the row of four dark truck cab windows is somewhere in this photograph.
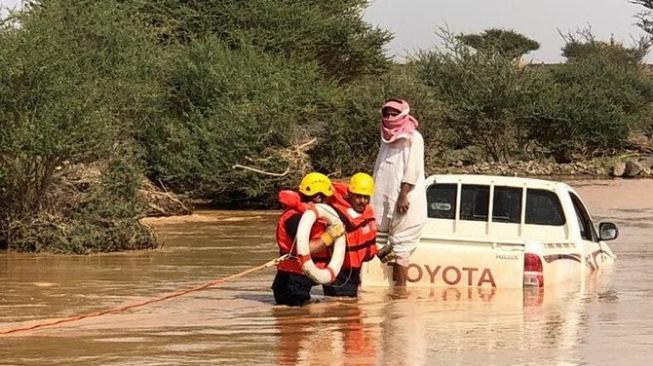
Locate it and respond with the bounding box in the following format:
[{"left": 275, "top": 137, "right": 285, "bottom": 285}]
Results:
[{"left": 526, "top": 189, "right": 565, "bottom": 226}]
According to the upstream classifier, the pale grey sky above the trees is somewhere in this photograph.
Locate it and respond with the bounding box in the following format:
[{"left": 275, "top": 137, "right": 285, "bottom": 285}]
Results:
[{"left": 0, "top": 0, "right": 653, "bottom": 63}]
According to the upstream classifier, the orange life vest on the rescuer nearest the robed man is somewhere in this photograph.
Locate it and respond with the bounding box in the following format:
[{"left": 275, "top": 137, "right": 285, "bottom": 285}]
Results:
[{"left": 330, "top": 182, "right": 377, "bottom": 269}]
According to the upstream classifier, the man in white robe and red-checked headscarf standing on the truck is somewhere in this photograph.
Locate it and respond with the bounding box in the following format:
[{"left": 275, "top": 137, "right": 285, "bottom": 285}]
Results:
[{"left": 371, "top": 99, "right": 427, "bottom": 286}]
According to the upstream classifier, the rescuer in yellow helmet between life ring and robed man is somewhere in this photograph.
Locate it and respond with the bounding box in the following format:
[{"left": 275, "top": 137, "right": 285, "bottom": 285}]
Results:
[{"left": 323, "top": 173, "right": 376, "bottom": 297}]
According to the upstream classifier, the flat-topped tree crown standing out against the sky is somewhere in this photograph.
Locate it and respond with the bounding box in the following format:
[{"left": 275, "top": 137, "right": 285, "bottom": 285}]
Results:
[{"left": 456, "top": 28, "right": 540, "bottom": 59}]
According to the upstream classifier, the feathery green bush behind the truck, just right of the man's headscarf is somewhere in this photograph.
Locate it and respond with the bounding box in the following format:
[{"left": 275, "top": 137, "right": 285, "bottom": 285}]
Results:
[{"left": 415, "top": 33, "right": 539, "bottom": 161}]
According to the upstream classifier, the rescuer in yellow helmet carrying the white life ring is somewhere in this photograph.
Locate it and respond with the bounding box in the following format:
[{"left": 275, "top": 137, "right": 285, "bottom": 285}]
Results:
[{"left": 272, "top": 172, "right": 344, "bottom": 306}]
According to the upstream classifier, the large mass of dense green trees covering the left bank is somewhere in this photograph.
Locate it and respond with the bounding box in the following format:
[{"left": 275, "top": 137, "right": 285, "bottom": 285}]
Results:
[{"left": 0, "top": 0, "right": 390, "bottom": 253}]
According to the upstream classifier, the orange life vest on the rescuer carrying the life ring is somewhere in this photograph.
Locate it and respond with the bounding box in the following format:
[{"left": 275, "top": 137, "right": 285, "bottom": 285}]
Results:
[{"left": 277, "top": 191, "right": 331, "bottom": 275}]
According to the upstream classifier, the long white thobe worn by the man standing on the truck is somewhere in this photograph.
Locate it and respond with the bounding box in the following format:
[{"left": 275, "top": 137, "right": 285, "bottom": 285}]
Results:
[{"left": 372, "top": 131, "right": 426, "bottom": 258}]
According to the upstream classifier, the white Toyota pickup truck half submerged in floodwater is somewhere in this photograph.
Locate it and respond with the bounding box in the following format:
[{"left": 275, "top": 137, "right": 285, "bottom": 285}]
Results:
[{"left": 361, "top": 175, "right": 618, "bottom": 288}]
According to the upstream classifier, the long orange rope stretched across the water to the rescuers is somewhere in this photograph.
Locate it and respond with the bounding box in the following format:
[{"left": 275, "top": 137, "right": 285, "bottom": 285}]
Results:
[{"left": 0, "top": 256, "right": 286, "bottom": 336}]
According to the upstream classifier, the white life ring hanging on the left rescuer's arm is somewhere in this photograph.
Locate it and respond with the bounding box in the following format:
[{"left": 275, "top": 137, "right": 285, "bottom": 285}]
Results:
[{"left": 296, "top": 203, "right": 347, "bottom": 284}]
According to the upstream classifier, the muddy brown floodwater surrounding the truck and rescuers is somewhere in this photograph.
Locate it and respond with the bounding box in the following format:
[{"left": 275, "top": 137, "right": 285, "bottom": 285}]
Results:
[{"left": 0, "top": 180, "right": 653, "bottom": 365}]
